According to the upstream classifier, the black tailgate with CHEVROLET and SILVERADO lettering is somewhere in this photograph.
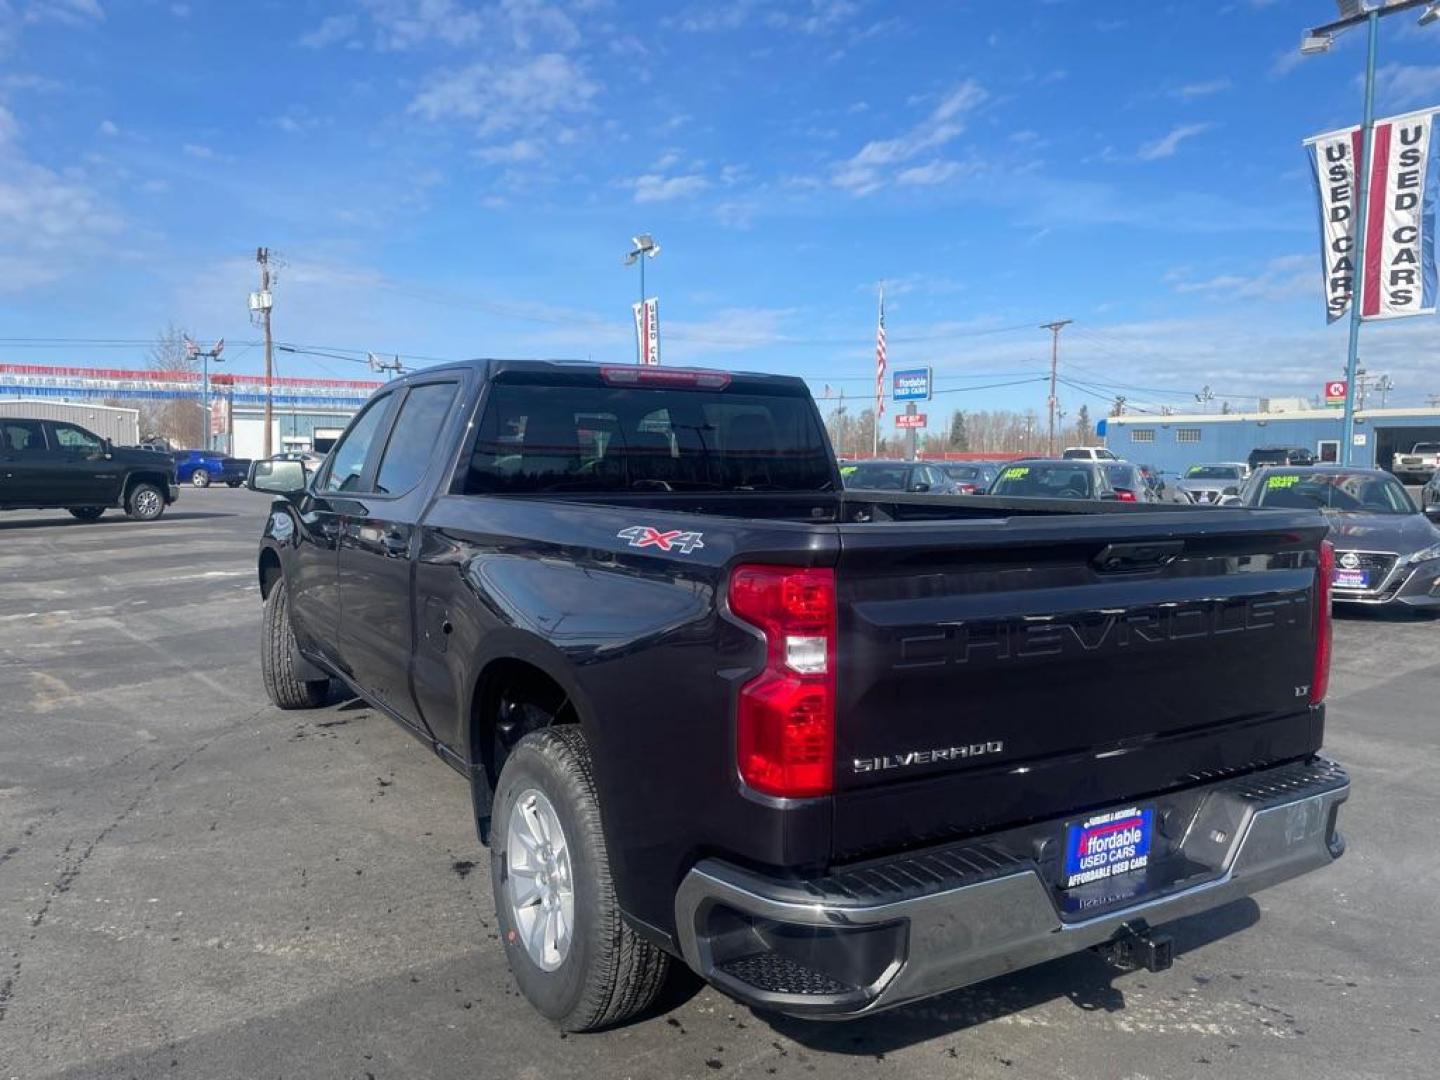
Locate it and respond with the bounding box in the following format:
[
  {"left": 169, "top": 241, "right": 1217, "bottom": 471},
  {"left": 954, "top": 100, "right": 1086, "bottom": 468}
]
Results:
[{"left": 834, "top": 510, "right": 1325, "bottom": 858}]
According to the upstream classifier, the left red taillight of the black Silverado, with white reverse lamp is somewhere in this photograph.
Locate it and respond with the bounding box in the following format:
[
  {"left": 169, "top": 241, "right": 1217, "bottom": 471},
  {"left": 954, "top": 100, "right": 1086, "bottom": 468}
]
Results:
[{"left": 730, "top": 566, "right": 835, "bottom": 798}]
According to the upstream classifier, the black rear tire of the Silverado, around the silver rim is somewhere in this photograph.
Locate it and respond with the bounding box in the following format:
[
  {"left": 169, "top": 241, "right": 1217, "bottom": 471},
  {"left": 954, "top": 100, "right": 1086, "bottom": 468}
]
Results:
[{"left": 490, "top": 726, "right": 670, "bottom": 1031}]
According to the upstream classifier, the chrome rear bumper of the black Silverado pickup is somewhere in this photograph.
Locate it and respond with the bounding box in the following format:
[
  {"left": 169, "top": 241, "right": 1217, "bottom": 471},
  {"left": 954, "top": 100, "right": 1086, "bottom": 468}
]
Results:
[{"left": 675, "top": 759, "right": 1349, "bottom": 1018}]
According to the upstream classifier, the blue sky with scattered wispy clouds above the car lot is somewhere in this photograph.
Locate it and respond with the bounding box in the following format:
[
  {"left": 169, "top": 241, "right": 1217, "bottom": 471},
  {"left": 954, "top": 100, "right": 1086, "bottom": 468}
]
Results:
[{"left": 0, "top": 0, "right": 1440, "bottom": 415}]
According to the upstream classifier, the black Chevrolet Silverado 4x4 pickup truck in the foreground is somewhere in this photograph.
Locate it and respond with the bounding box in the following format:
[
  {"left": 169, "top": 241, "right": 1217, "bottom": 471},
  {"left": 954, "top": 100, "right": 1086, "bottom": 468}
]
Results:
[{"left": 249, "top": 360, "right": 1349, "bottom": 1030}]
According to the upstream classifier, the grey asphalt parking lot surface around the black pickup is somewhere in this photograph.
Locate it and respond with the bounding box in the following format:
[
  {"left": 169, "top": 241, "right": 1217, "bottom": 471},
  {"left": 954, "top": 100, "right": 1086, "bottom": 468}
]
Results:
[{"left": 0, "top": 488, "right": 1440, "bottom": 1080}]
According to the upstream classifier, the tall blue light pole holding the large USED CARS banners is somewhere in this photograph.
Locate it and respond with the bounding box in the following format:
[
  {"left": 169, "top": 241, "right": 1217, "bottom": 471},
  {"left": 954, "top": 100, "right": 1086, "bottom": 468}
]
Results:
[{"left": 1300, "top": 0, "right": 1440, "bottom": 465}]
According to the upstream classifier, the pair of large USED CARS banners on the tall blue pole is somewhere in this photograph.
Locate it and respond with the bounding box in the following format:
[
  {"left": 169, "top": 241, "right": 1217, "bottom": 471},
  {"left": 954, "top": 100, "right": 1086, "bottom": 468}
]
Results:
[{"left": 1305, "top": 109, "right": 1440, "bottom": 323}]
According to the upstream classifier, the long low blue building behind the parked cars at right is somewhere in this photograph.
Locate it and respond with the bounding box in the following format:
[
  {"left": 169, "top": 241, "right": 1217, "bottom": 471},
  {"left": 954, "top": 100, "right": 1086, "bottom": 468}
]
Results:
[{"left": 1097, "top": 408, "right": 1440, "bottom": 475}]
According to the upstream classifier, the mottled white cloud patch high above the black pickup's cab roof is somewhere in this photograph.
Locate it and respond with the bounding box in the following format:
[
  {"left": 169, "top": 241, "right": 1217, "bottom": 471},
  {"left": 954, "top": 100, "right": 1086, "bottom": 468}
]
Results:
[{"left": 410, "top": 53, "right": 600, "bottom": 134}]
